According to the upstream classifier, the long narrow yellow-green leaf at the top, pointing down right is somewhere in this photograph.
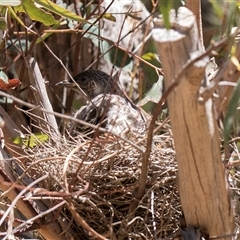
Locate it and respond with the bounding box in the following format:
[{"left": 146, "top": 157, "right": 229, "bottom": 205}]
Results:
[{"left": 35, "top": 0, "right": 85, "bottom": 22}]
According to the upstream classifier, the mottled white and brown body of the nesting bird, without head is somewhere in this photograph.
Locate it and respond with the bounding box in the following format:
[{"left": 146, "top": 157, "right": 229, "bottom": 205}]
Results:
[{"left": 73, "top": 94, "right": 146, "bottom": 136}]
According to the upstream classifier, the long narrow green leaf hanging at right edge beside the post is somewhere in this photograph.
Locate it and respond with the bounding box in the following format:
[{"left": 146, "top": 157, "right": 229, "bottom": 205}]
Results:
[{"left": 223, "top": 79, "right": 240, "bottom": 145}]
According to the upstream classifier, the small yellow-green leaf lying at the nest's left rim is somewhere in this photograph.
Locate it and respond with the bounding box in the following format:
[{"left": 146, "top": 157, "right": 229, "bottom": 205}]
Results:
[{"left": 12, "top": 133, "right": 49, "bottom": 148}]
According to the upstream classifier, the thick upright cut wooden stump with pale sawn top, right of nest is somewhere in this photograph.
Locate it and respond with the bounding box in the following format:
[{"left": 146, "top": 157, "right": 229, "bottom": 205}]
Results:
[{"left": 153, "top": 7, "right": 234, "bottom": 239}]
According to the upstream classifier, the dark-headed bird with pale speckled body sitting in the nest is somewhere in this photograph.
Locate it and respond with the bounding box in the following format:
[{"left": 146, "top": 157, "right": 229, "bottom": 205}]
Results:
[{"left": 56, "top": 69, "right": 146, "bottom": 136}]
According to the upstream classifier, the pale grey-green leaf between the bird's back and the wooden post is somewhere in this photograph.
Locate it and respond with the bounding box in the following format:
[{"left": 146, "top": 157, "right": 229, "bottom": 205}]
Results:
[{"left": 137, "top": 75, "right": 163, "bottom": 106}]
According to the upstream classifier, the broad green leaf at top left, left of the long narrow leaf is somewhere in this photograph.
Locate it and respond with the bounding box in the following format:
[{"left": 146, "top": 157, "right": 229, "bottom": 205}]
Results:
[{"left": 14, "top": 0, "right": 58, "bottom": 26}]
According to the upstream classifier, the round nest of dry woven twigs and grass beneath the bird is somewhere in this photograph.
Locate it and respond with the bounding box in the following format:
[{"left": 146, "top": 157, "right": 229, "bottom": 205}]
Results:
[{"left": 11, "top": 123, "right": 181, "bottom": 239}]
